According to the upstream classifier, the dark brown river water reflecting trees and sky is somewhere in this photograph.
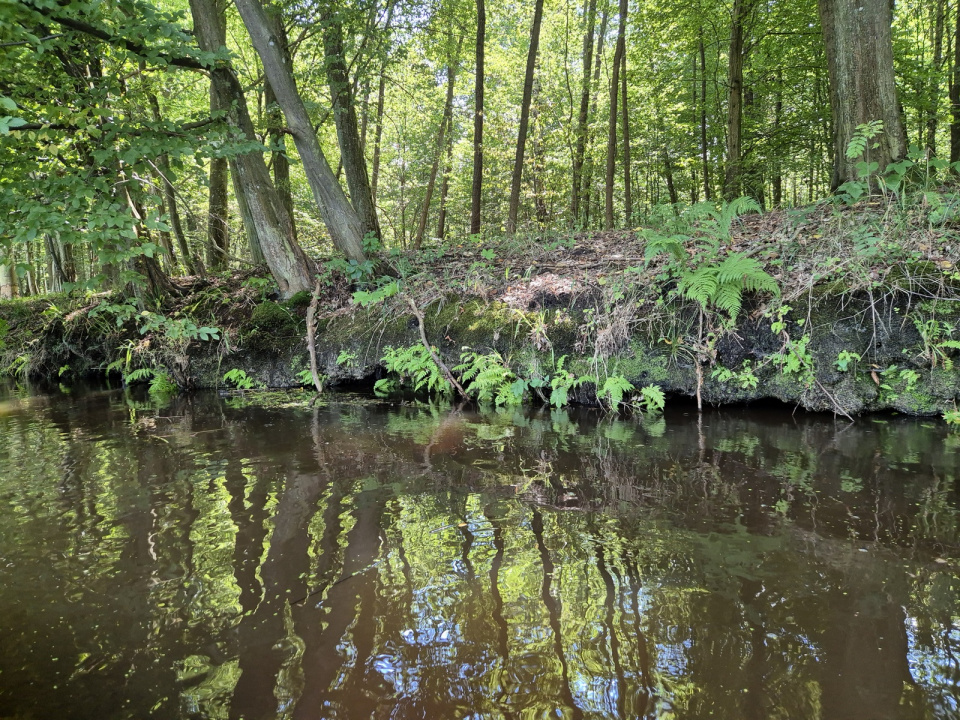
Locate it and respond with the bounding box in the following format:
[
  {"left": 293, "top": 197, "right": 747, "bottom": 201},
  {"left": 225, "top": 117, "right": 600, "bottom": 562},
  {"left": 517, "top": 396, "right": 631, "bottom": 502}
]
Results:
[{"left": 0, "top": 391, "right": 960, "bottom": 720}]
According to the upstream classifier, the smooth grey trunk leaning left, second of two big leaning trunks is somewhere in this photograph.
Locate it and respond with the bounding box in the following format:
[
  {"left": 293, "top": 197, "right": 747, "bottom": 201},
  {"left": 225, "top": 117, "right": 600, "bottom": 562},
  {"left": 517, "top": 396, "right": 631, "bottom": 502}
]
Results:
[{"left": 232, "top": 0, "right": 366, "bottom": 268}]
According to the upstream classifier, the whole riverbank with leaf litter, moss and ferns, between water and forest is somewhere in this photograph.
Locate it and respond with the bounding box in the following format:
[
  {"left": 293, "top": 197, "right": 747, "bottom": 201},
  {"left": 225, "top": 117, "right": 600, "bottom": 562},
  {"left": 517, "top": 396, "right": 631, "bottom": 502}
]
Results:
[{"left": 0, "top": 200, "right": 960, "bottom": 416}]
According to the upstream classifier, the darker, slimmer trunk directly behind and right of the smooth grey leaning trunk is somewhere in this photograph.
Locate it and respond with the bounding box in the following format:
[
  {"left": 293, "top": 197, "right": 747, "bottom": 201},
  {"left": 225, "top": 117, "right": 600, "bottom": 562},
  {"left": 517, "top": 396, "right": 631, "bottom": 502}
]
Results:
[{"left": 324, "top": 3, "right": 380, "bottom": 240}]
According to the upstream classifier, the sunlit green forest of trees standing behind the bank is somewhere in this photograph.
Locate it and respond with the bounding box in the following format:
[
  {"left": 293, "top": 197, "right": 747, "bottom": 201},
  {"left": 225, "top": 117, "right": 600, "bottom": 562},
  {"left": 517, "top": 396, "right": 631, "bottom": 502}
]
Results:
[{"left": 0, "top": 0, "right": 960, "bottom": 298}]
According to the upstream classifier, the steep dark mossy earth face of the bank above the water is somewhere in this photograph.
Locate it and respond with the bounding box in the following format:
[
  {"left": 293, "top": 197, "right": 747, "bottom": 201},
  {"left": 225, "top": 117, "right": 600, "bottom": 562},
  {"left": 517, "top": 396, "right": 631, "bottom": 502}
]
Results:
[{"left": 0, "top": 281, "right": 960, "bottom": 415}]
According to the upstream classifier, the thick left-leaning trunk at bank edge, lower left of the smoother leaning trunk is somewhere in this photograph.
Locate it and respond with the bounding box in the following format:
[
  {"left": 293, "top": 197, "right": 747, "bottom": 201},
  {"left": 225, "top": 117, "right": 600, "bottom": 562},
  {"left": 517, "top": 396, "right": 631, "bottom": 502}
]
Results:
[{"left": 190, "top": 0, "right": 316, "bottom": 297}]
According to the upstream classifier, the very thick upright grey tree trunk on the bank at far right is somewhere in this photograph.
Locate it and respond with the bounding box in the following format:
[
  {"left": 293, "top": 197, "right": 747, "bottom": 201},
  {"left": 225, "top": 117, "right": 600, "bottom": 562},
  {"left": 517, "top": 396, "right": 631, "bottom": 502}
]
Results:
[{"left": 819, "top": 0, "right": 907, "bottom": 190}]
